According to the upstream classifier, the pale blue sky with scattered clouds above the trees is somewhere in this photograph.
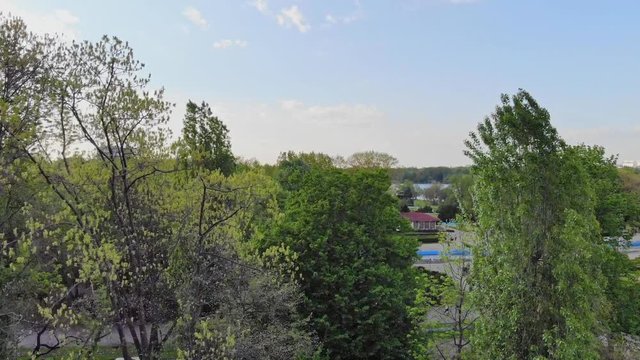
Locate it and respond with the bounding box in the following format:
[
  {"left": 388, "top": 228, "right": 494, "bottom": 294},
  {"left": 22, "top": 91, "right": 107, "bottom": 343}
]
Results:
[{"left": 0, "top": 0, "right": 640, "bottom": 166}]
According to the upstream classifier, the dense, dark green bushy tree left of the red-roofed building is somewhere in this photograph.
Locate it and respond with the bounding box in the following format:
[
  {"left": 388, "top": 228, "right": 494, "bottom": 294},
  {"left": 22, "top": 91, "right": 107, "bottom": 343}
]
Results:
[{"left": 263, "top": 167, "right": 417, "bottom": 359}]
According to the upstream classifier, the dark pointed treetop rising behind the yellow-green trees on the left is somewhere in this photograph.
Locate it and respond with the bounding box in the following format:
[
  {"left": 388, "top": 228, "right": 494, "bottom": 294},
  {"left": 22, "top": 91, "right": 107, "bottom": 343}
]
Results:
[{"left": 182, "top": 100, "right": 235, "bottom": 175}]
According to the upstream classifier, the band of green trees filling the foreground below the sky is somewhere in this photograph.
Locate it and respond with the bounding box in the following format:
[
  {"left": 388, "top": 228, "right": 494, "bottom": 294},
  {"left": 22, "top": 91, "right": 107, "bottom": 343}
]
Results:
[{"left": 0, "top": 13, "right": 640, "bottom": 359}]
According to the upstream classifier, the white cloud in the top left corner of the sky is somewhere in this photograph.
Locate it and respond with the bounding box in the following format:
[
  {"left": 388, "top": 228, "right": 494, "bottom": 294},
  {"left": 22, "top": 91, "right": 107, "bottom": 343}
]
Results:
[{"left": 0, "top": 0, "right": 80, "bottom": 40}]
